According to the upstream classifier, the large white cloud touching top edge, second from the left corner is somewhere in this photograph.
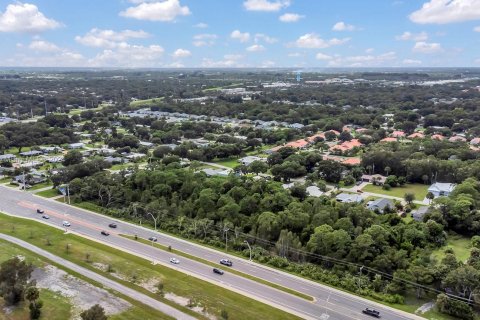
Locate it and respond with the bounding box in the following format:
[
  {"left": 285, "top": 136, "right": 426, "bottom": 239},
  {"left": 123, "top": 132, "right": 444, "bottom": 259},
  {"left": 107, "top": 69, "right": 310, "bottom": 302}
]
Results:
[{"left": 120, "top": 0, "right": 191, "bottom": 21}]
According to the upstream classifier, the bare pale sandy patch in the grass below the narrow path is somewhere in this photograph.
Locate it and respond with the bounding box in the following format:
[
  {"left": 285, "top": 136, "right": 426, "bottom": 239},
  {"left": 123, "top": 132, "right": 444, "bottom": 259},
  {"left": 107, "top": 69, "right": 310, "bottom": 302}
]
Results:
[{"left": 32, "top": 265, "right": 131, "bottom": 319}]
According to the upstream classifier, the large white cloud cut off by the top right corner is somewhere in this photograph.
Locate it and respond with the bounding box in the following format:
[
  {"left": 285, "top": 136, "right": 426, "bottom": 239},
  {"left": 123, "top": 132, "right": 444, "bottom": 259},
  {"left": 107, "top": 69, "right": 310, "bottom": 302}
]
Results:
[{"left": 409, "top": 0, "right": 480, "bottom": 24}]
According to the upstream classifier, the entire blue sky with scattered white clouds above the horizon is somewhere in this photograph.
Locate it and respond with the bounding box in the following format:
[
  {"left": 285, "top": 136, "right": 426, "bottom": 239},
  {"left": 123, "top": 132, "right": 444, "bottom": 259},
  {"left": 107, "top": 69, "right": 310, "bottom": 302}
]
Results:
[{"left": 0, "top": 0, "right": 480, "bottom": 68}]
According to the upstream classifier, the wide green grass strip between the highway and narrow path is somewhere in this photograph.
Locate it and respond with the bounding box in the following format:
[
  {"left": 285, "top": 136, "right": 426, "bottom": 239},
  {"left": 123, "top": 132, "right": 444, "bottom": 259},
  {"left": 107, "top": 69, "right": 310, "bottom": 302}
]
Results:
[{"left": 0, "top": 214, "right": 298, "bottom": 320}]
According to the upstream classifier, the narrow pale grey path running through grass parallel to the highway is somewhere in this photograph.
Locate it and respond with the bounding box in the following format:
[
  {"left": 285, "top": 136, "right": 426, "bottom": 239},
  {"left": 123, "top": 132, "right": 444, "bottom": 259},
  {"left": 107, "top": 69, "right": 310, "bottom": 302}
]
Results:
[{"left": 0, "top": 233, "right": 196, "bottom": 320}]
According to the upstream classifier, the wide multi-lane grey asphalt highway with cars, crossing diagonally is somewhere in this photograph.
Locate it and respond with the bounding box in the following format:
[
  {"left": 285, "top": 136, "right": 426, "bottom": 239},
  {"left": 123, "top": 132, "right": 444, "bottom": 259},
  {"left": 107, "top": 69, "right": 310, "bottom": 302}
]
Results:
[{"left": 0, "top": 186, "right": 423, "bottom": 320}]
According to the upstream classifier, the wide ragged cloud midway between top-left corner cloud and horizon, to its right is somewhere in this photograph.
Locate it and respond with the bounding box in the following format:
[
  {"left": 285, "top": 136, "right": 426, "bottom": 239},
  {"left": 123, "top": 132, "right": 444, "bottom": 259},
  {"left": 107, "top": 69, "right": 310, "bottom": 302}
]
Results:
[{"left": 75, "top": 28, "right": 150, "bottom": 48}]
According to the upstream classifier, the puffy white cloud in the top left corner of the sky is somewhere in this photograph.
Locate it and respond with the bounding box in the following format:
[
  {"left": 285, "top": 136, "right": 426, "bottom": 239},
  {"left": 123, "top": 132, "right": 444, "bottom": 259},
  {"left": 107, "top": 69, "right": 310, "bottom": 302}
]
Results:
[{"left": 0, "top": 2, "right": 61, "bottom": 33}]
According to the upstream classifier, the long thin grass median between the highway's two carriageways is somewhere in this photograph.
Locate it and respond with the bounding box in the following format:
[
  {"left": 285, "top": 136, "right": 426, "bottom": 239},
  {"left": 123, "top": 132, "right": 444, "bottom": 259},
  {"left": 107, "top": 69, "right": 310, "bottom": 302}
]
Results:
[{"left": 121, "top": 234, "right": 313, "bottom": 301}]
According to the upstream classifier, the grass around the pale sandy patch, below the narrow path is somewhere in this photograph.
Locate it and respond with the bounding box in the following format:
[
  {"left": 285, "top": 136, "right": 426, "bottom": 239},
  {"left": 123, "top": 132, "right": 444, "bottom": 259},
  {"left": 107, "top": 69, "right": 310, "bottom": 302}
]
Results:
[{"left": 0, "top": 239, "right": 173, "bottom": 320}]
